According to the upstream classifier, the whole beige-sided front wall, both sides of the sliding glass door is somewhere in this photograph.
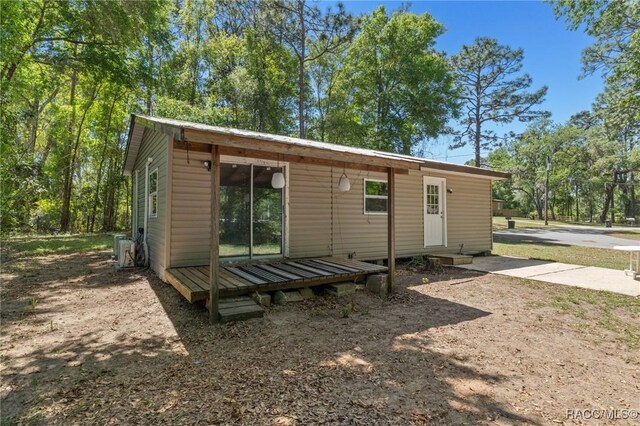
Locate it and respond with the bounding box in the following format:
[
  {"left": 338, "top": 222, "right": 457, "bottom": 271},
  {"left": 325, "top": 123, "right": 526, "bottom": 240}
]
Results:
[{"left": 168, "top": 149, "right": 492, "bottom": 267}]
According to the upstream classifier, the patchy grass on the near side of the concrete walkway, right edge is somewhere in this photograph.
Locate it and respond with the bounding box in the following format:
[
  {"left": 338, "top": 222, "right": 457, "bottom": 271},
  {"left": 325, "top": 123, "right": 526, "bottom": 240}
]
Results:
[{"left": 535, "top": 287, "right": 640, "bottom": 348}]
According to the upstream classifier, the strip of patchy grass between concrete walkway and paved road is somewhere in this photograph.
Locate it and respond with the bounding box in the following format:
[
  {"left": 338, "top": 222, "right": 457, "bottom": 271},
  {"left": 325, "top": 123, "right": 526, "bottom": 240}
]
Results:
[{"left": 491, "top": 238, "right": 629, "bottom": 269}]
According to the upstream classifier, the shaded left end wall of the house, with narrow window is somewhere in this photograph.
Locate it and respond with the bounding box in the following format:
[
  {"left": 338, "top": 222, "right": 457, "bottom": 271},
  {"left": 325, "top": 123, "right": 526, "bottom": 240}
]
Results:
[{"left": 133, "top": 129, "right": 168, "bottom": 278}]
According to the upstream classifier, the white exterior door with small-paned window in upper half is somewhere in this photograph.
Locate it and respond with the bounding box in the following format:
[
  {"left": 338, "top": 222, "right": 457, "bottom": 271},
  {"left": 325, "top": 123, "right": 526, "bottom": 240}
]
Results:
[{"left": 423, "top": 176, "right": 447, "bottom": 247}]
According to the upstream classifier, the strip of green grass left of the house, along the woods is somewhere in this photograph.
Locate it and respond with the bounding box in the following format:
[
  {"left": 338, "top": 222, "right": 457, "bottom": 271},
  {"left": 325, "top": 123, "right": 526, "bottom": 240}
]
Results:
[{"left": 2, "top": 234, "right": 113, "bottom": 258}]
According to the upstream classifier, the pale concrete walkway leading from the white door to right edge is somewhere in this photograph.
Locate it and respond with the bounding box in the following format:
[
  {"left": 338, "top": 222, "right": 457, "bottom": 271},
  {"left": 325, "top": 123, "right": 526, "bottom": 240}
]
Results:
[{"left": 457, "top": 256, "right": 640, "bottom": 296}]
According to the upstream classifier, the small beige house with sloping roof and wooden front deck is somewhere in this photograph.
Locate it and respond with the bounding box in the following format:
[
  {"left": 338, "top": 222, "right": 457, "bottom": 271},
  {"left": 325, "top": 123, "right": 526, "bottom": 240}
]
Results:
[{"left": 124, "top": 115, "right": 509, "bottom": 318}]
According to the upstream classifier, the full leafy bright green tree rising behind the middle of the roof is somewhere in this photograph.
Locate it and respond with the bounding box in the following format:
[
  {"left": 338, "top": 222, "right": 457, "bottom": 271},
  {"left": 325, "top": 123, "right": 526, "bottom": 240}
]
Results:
[{"left": 330, "top": 7, "right": 457, "bottom": 154}]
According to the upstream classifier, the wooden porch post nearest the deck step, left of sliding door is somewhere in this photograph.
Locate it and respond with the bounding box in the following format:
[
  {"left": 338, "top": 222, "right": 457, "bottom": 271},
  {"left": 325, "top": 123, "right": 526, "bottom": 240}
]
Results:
[{"left": 209, "top": 145, "right": 220, "bottom": 324}]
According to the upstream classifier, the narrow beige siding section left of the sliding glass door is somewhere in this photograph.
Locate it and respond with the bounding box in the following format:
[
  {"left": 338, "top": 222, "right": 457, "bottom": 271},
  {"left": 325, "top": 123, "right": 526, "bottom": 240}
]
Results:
[{"left": 170, "top": 149, "right": 211, "bottom": 267}]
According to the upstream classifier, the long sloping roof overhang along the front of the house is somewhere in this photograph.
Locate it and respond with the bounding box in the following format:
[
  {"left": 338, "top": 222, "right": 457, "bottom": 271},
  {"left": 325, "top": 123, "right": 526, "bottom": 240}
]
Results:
[{"left": 123, "top": 114, "right": 509, "bottom": 179}]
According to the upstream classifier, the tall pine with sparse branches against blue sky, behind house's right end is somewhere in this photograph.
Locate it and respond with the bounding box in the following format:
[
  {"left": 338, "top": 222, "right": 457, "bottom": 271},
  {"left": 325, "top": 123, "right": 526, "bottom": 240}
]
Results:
[{"left": 451, "top": 38, "right": 547, "bottom": 167}]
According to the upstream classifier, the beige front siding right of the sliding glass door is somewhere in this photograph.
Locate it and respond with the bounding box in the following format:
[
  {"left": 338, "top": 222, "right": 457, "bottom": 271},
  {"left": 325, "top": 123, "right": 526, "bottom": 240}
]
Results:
[{"left": 289, "top": 164, "right": 491, "bottom": 260}]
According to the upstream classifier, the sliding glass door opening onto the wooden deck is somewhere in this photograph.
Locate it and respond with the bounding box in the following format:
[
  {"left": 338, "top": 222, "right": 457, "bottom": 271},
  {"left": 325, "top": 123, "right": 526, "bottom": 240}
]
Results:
[{"left": 220, "top": 163, "right": 284, "bottom": 258}]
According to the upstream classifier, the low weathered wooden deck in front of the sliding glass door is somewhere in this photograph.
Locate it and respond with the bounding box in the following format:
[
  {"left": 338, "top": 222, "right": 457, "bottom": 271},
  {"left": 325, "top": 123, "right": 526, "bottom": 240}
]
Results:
[{"left": 165, "top": 257, "right": 387, "bottom": 302}]
